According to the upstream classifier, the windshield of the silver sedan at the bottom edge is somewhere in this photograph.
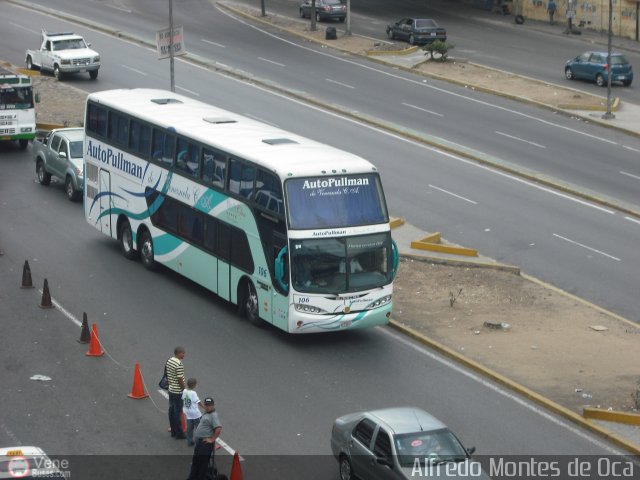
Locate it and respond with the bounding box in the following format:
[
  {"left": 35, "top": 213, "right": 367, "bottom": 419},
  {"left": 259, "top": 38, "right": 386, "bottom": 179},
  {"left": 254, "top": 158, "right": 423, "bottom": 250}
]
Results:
[{"left": 395, "top": 428, "right": 469, "bottom": 467}]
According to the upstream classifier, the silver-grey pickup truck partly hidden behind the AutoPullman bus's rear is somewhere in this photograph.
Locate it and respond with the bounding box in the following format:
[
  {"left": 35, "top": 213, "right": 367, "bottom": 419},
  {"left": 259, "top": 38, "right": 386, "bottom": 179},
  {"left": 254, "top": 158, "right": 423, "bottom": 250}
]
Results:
[{"left": 32, "top": 128, "right": 84, "bottom": 201}]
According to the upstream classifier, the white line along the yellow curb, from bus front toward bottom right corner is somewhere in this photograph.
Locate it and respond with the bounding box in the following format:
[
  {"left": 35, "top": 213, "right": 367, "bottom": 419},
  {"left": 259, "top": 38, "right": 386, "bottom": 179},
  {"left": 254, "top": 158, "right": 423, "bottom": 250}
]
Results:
[{"left": 376, "top": 327, "right": 626, "bottom": 455}]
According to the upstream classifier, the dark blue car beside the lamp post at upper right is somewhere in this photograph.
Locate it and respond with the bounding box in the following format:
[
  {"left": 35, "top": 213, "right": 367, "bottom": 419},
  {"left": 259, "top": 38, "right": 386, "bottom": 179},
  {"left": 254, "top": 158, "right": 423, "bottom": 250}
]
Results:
[{"left": 564, "top": 52, "right": 633, "bottom": 87}]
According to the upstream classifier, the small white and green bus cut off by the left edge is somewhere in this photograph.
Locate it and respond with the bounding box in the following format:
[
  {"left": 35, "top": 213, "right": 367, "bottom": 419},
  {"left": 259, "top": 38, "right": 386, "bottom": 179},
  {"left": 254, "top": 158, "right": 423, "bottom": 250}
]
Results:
[{"left": 0, "top": 67, "right": 36, "bottom": 150}]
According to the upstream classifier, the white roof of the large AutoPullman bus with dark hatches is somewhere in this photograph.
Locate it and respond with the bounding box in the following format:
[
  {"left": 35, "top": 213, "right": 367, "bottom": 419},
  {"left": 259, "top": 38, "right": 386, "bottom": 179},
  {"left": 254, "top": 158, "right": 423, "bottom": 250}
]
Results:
[{"left": 87, "top": 89, "right": 377, "bottom": 179}]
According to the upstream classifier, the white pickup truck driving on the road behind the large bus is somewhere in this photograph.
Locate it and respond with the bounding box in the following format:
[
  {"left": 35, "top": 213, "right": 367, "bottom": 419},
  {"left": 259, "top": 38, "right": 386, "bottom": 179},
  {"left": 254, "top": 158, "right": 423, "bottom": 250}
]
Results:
[{"left": 26, "top": 30, "right": 100, "bottom": 80}]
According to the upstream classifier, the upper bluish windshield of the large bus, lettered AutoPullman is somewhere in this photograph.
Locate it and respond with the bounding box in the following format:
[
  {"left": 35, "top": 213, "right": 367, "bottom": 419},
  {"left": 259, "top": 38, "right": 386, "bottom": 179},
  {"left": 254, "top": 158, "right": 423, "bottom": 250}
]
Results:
[{"left": 285, "top": 173, "right": 389, "bottom": 230}]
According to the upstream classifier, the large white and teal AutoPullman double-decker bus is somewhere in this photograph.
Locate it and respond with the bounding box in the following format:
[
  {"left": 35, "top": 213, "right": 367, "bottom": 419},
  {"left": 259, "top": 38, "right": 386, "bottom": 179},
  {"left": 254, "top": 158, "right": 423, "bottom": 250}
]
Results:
[{"left": 84, "top": 89, "right": 398, "bottom": 333}]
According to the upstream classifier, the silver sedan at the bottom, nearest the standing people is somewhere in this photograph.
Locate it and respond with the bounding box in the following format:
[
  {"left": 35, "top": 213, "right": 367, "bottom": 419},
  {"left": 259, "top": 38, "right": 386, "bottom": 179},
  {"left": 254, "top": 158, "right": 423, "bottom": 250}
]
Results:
[{"left": 331, "top": 407, "right": 489, "bottom": 480}]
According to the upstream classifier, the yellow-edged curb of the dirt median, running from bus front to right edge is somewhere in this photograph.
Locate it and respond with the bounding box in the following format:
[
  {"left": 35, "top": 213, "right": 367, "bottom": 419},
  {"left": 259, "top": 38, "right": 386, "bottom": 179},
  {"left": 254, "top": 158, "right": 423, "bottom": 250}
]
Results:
[{"left": 389, "top": 319, "right": 640, "bottom": 455}]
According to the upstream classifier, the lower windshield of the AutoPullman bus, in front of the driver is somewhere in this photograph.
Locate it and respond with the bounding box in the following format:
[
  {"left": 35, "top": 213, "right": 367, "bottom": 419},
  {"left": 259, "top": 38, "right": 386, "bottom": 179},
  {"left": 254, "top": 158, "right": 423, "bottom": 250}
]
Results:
[{"left": 291, "top": 232, "right": 392, "bottom": 293}]
